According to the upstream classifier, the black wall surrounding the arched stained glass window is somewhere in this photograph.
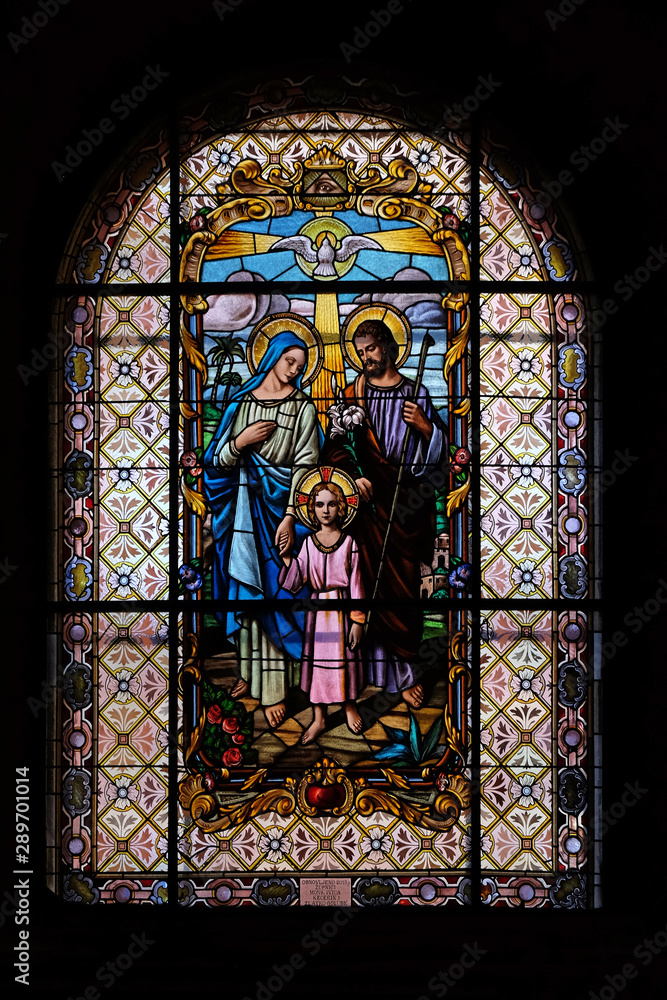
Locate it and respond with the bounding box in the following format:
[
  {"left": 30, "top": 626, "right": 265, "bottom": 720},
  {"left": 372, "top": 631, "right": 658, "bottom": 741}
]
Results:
[{"left": 0, "top": 0, "right": 667, "bottom": 1000}]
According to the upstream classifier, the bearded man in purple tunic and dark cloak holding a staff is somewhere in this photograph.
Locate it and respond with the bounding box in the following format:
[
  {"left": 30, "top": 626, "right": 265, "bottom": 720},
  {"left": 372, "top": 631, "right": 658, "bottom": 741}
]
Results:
[{"left": 322, "top": 320, "right": 447, "bottom": 708}]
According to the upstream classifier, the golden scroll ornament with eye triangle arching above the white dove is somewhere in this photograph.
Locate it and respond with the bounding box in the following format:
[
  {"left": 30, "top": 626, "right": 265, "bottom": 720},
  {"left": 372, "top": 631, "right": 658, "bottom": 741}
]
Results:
[{"left": 180, "top": 145, "right": 470, "bottom": 419}]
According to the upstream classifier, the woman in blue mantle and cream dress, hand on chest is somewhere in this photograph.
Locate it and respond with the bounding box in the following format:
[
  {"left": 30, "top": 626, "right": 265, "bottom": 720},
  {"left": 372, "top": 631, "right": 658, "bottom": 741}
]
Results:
[{"left": 204, "top": 328, "right": 323, "bottom": 727}]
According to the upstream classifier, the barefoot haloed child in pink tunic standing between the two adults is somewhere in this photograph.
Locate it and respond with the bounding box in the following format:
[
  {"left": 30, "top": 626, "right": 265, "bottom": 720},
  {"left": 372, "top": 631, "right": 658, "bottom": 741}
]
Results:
[{"left": 279, "top": 470, "right": 366, "bottom": 744}]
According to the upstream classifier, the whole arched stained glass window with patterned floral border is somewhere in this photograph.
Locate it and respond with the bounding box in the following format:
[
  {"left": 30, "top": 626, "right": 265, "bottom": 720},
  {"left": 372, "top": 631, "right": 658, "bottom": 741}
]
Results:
[{"left": 50, "top": 82, "right": 599, "bottom": 908}]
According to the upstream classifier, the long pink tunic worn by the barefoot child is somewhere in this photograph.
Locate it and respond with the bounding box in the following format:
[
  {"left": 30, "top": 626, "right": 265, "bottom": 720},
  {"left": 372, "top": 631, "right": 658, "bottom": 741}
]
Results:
[{"left": 279, "top": 535, "right": 364, "bottom": 705}]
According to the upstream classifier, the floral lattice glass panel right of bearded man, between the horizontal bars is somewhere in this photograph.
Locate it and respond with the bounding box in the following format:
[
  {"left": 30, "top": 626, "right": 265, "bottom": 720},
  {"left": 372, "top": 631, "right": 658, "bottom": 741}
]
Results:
[{"left": 479, "top": 293, "right": 556, "bottom": 599}]
